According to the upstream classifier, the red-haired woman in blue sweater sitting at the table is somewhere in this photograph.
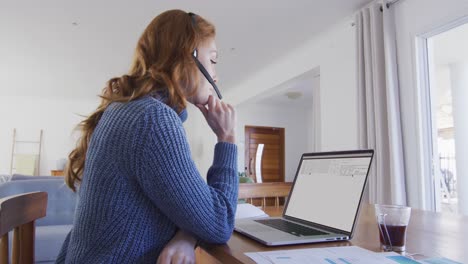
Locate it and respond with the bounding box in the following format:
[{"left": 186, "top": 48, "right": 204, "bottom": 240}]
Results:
[{"left": 57, "top": 10, "right": 238, "bottom": 263}]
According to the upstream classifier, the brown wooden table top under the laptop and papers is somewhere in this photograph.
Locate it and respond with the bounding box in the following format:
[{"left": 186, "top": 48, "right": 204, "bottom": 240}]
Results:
[{"left": 203, "top": 205, "right": 468, "bottom": 263}]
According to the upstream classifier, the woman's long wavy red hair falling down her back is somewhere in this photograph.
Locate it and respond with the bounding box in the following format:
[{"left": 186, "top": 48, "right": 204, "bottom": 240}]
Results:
[{"left": 65, "top": 10, "right": 215, "bottom": 192}]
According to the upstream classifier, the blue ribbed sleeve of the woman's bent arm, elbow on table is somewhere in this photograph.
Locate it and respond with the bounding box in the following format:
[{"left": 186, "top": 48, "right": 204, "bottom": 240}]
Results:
[{"left": 136, "top": 104, "right": 238, "bottom": 243}]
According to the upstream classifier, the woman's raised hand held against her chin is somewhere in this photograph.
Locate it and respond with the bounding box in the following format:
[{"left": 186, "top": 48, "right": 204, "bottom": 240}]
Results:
[{"left": 197, "top": 95, "right": 236, "bottom": 143}]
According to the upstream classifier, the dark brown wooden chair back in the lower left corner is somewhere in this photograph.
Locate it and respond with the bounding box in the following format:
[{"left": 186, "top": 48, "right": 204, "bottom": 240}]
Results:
[{"left": 0, "top": 192, "right": 47, "bottom": 264}]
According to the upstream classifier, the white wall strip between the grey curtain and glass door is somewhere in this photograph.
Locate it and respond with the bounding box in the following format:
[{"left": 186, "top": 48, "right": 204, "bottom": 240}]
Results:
[{"left": 392, "top": 0, "right": 468, "bottom": 208}]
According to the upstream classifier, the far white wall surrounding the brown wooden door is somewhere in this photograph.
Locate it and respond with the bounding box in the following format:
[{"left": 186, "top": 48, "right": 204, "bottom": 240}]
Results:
[{"left": 236, "top": 104, "right": 308, "bottom": 182}]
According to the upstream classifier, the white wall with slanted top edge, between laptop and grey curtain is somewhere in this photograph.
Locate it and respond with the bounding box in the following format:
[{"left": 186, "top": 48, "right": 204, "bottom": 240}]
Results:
[{"left": 226, "top": 19, "right": 357, "bottom": 153}]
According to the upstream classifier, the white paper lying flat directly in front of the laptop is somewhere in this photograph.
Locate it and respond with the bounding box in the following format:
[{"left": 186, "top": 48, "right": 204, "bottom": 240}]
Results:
[{"left": 245, "top": 246, "right": 418, "bottom": 264}]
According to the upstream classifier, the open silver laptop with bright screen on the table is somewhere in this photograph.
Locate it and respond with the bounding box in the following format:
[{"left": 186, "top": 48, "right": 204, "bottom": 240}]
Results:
[{"left": 234, "top": 150, "right": 374, "bottom": 246}]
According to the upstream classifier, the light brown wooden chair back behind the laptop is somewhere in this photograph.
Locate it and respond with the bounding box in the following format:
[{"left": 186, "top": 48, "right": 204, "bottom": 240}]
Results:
[{"left": 239, "top": 182, "right": 292, "bottom": 207}]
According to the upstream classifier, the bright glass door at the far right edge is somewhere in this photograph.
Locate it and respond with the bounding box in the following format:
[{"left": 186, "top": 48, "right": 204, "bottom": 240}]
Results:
[{"left": 427, "top": 21, "right": 468, "bottom": 214}]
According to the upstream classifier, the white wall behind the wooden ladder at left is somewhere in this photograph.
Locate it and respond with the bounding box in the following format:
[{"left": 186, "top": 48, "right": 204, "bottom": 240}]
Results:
[{"left": 0, "top": 96, "right": 99, "bottom": 175}]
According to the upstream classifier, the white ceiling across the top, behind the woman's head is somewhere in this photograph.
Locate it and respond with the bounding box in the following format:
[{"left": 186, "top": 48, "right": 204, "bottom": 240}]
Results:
[{"left": 0, "top": 0, "right": 370, "bottom": 98}]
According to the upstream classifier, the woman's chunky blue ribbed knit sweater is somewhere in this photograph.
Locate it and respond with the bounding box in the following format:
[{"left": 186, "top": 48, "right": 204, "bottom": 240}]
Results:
[{"left": 57, "top": 96, "right": 238, "bottom": 264}]
